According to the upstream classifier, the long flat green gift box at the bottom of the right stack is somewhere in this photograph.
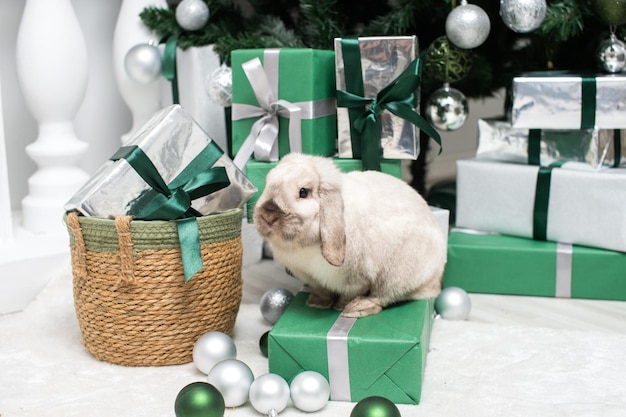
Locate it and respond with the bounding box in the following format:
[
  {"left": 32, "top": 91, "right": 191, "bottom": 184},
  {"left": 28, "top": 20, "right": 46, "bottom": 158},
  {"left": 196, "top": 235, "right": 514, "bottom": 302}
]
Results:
[{"left": 443, "top": 230, "right": 626, "bottom": 300}]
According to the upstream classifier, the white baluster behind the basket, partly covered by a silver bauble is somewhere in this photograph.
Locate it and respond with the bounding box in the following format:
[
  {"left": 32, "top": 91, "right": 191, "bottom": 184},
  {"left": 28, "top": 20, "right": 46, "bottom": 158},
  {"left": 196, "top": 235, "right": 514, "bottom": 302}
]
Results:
[{"left": 113, "top": 0, "right": 167, "bottom": 144}]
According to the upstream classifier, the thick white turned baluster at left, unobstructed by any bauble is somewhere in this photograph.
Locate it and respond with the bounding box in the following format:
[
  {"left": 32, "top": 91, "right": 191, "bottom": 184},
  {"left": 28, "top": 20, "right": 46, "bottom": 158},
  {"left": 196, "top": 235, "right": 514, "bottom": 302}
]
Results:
[{"left": 16, "top": 0, "right": 88, "bottom": 233}]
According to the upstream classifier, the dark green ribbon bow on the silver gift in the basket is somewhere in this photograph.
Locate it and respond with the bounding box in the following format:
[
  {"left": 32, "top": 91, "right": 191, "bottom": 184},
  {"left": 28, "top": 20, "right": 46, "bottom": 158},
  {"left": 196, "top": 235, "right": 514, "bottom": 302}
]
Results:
[{"left": 110, "top": 142, "right": 230, "bottom": 282}]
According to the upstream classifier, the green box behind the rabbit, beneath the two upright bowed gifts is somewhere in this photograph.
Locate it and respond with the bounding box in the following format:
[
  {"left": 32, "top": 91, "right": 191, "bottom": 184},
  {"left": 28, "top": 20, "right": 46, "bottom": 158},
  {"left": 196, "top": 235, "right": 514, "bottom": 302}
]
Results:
[{"left": 246, "top": 158, "right": 402, "bottom": 223}]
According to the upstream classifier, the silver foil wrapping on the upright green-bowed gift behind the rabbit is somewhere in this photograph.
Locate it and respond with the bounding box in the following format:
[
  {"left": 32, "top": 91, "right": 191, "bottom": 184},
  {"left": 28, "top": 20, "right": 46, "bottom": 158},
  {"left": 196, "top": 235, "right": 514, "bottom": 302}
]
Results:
[{"left": 335, "top": 36, "right": 419, "bottom": 159}]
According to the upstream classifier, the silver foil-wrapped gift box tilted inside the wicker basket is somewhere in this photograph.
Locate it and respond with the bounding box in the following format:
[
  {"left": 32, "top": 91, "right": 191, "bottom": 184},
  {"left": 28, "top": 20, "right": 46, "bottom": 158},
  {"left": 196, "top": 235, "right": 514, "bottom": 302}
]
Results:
[{"left": 64, "top": 105, "right": 257, "bottom": 218}]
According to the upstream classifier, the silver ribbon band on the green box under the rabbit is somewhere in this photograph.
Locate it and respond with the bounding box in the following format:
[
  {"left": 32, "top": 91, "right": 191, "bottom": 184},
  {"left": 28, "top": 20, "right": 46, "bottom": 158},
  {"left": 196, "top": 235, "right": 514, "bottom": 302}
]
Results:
[{"left": 326, "top": 316, "right": 357, "bottom": 401}]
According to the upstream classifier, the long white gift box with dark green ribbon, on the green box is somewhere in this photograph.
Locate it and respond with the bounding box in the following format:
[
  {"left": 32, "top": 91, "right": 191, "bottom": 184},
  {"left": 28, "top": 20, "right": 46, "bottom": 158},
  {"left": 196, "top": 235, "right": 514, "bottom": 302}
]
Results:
[{"left": 456, "top": 159, "right": 626, "bottom": 252}]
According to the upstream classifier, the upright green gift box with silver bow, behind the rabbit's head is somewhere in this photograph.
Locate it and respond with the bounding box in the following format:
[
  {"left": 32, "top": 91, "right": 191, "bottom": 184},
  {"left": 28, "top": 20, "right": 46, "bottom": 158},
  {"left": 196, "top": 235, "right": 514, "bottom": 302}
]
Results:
[{"left": 231, "top": 48, "right": 337, "bottom": 166}]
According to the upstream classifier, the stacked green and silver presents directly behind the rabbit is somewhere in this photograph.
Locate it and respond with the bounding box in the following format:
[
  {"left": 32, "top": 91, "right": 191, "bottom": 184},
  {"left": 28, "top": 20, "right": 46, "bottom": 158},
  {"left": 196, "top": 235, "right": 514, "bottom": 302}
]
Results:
[{"left": 231, "top": 36, "right": 439, "bottom": 222}]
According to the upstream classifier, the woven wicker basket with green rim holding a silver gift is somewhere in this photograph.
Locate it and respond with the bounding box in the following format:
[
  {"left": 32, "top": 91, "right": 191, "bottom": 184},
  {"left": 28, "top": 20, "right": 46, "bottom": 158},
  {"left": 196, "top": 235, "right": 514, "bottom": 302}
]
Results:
[{"left": 65, "top": 209, "right": 243, "bottom": 366}]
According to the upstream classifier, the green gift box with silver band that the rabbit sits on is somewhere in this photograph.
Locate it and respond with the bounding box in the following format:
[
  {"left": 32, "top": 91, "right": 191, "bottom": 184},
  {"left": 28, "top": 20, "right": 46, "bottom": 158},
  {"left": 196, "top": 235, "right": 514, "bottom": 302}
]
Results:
[{"left": 268, "top": 292, "right": 434, "bottom": 404}]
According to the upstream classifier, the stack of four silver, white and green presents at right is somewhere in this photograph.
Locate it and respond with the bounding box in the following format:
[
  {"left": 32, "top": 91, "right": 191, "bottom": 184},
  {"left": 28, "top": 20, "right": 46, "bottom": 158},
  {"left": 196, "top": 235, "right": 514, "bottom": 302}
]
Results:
[{"left": 444, "top": 72, "right": 626, "bottom": 300}]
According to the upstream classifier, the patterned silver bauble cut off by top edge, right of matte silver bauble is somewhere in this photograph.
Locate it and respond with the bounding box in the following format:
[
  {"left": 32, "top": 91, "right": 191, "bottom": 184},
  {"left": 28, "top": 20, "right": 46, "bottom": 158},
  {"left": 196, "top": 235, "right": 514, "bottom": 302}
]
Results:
[{"left": 500, "top": 0, "right": 548, "bottom": 33}]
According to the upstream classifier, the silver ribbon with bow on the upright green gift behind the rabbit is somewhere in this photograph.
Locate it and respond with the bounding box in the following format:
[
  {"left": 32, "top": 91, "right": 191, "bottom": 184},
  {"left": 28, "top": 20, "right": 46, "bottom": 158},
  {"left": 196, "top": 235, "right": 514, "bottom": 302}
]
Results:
[{"left": 232, "top": 48, "right": 336, "bottom": 169}]
